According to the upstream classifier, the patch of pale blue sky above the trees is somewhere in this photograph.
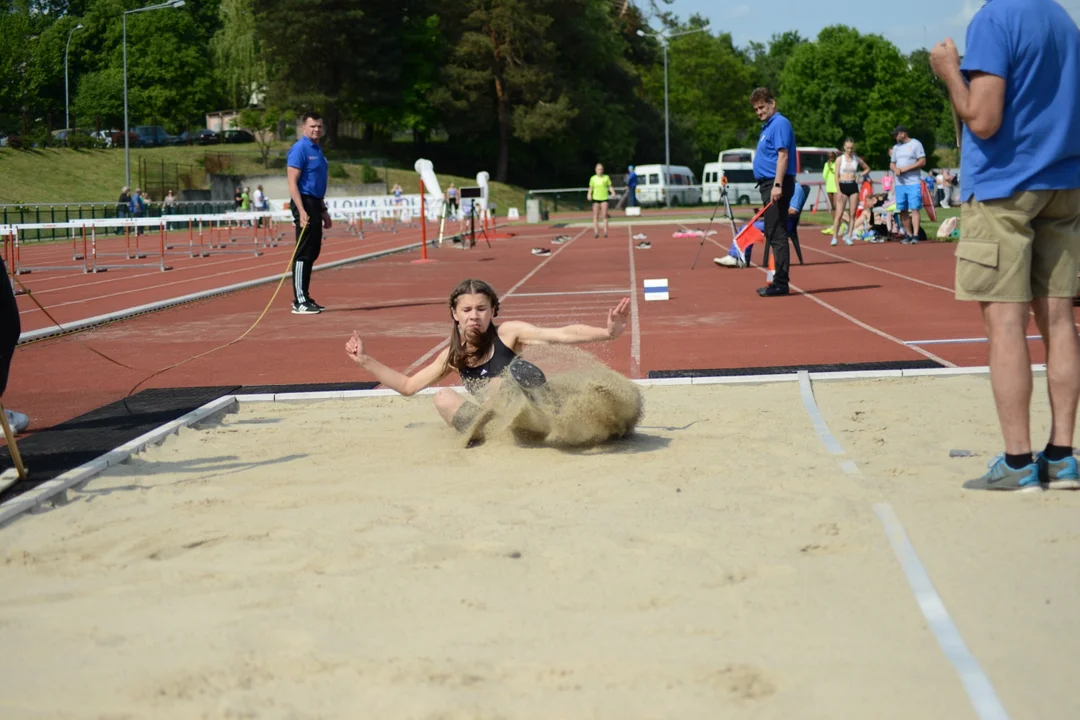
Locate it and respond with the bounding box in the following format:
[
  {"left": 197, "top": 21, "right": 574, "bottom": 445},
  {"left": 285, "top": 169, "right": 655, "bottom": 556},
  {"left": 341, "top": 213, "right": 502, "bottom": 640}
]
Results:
[{"left": 656, "top": 0, "right": 1080, "bottom": 53}]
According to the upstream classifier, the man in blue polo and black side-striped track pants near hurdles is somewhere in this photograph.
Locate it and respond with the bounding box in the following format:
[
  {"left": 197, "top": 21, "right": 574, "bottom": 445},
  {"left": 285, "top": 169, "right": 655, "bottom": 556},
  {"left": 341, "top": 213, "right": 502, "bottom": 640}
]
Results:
[{"left": 286, "top": 112, "right": 332, "bottom": 315}]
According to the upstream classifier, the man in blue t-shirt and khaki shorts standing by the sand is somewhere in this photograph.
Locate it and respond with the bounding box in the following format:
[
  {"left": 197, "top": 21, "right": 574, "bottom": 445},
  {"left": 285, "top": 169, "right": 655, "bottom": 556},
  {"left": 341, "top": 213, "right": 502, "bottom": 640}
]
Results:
[{"left": 930, "top": 0, "right": 1080, "bottom": 491}]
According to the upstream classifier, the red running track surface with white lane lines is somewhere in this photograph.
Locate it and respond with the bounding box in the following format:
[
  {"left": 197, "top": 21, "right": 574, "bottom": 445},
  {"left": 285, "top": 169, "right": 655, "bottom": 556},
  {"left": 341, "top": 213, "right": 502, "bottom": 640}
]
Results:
[{"left": 4, "top": 216, "right": 1075, "bottom": 432}]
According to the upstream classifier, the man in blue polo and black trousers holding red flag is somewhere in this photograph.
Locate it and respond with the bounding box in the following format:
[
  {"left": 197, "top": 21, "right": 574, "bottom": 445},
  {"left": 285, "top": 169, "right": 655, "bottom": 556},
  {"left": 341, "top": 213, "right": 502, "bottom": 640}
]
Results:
[{"left": 750, "top": 87, "right": 796, "bottom": 298}]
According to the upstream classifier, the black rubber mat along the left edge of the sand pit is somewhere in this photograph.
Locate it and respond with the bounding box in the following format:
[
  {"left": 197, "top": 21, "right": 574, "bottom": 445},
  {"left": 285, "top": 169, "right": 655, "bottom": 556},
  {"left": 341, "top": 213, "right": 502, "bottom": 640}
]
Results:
[{"left": 0, "top": 385, "right": 237, "bottom": 502}]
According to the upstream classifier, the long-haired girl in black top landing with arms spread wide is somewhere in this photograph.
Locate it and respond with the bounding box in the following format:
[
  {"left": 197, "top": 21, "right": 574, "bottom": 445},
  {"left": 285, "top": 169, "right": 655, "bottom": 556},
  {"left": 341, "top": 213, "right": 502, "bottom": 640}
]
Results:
[{"left": 346, "top": 280, "right": 630, "bottom": 432}]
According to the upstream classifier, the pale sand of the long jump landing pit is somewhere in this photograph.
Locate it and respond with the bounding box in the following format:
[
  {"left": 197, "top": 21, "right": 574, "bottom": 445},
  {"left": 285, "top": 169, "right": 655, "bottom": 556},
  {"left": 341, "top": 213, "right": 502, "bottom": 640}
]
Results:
[{"left": 0, "top": 376, "right": 1080, "bottom": 720}]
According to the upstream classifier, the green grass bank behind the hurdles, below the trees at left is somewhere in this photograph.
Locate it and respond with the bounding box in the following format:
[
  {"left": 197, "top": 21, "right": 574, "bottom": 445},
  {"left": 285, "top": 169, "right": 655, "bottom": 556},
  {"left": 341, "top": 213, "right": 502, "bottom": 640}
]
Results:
[{"left": 0, "top": 144, "right": 525, "bottom": 212}]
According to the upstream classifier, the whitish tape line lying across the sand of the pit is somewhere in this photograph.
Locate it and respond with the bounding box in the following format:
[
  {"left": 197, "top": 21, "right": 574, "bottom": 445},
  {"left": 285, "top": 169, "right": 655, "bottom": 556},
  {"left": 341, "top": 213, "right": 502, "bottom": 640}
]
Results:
[{"left": 799, "top": 370, "right": 1009, "bottom": 720}]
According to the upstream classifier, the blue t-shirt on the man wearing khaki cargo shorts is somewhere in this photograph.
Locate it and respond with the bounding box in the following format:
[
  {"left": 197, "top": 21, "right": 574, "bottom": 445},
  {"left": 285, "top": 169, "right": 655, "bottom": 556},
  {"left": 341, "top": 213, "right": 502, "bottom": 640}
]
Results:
[{"left": 960, "top": 0, "right": 1080, "bottom": 202}]
